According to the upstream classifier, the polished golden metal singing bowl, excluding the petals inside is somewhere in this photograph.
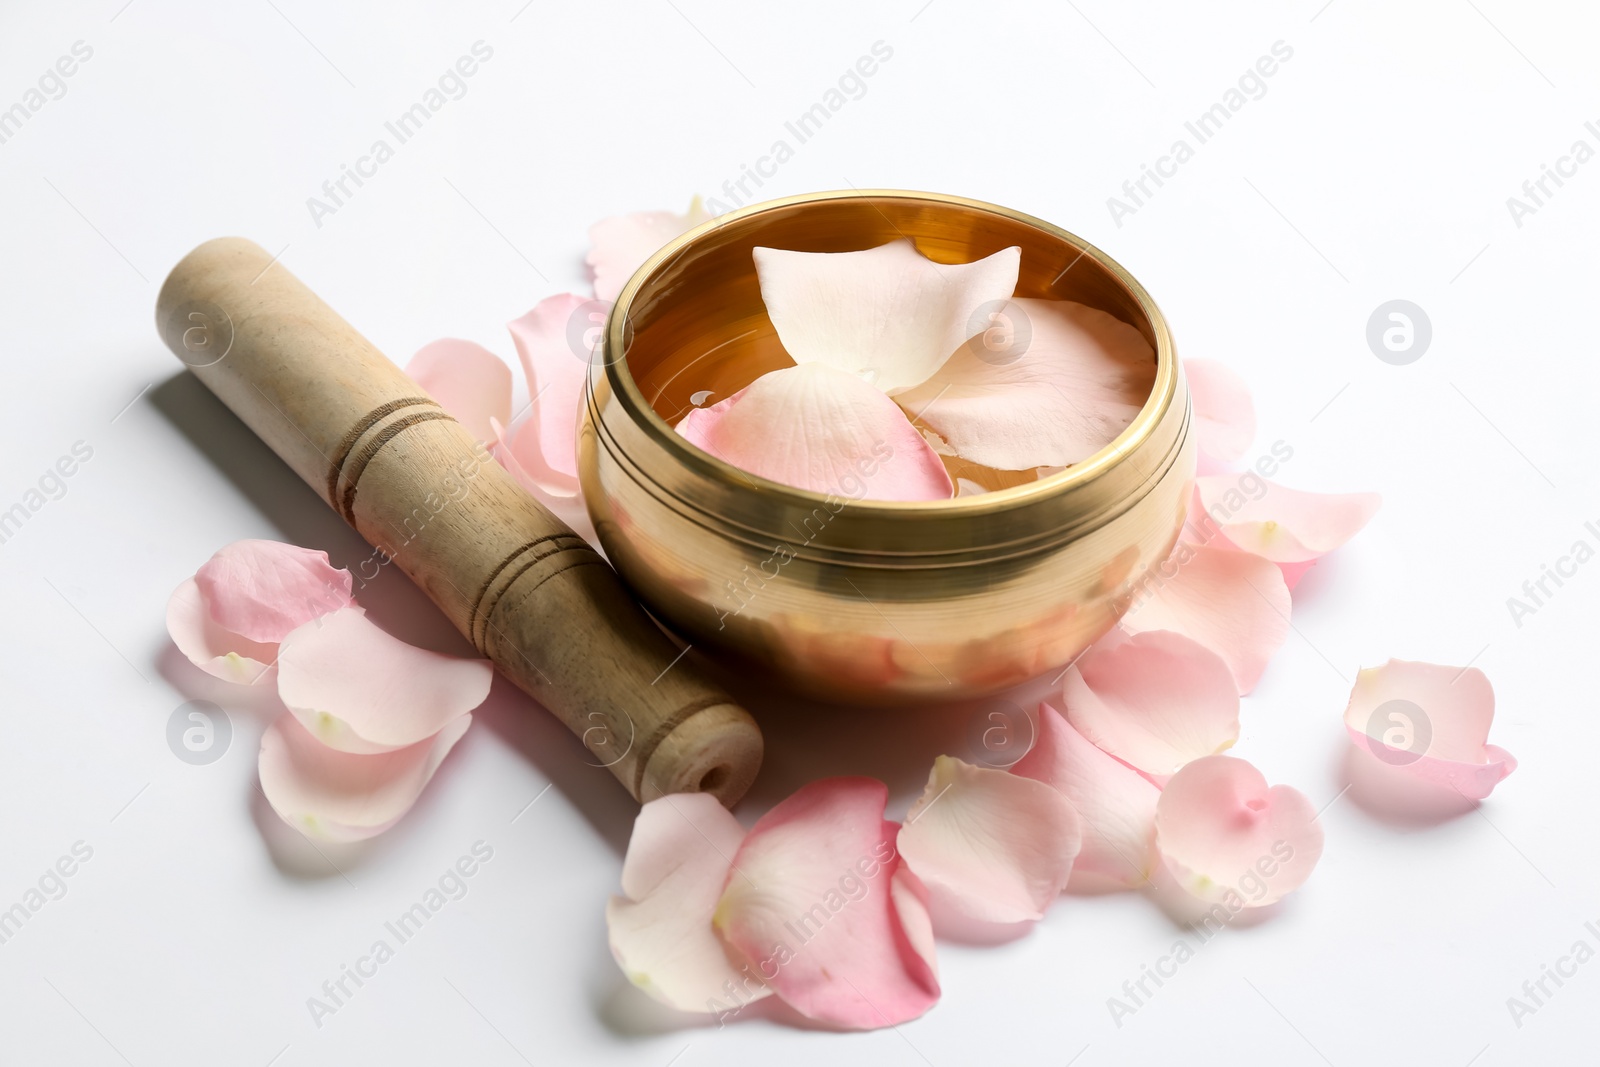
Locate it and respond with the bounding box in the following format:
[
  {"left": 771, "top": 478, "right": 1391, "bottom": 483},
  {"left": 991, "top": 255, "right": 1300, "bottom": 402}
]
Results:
[{"left": 578, "top": 190, "right": 1194, "bottom": 704}]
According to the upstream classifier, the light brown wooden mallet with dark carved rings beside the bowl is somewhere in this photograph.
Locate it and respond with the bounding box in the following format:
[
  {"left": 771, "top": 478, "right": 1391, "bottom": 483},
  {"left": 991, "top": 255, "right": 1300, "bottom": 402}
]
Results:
[{"left": 157, "top": 238, "right": 762, "bottom": 805}]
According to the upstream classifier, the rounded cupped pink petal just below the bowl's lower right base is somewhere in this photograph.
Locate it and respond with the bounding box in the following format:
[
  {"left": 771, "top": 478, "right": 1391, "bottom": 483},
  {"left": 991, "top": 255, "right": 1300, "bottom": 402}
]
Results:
[{"left": 1061, "top": 630, "right": 1238, "bottom": 776}]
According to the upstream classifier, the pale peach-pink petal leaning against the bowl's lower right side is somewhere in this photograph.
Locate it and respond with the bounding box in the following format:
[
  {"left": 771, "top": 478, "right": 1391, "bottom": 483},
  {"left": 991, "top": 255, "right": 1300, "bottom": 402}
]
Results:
[{"left": 1122, "top": 541, "right": 1290, "bottom": 694}]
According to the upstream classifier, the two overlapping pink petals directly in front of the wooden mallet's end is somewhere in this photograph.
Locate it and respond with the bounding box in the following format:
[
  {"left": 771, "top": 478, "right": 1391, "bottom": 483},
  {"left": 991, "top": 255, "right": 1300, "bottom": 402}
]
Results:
[{"left": 606, "top": 777, "right": 939, "bottom": 1029}]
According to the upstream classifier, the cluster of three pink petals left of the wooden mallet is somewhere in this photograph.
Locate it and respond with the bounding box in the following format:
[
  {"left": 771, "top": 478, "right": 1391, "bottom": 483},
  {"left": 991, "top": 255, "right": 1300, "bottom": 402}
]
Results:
[{"left": 166, "top": 541, "right": 493, "bottom": 841}]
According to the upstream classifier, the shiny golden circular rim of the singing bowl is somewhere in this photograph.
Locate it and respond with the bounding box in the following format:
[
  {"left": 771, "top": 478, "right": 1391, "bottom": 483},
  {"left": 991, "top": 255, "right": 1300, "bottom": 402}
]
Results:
[{"left": 604, "top": 189, "right": 1179, "bottom": 520}]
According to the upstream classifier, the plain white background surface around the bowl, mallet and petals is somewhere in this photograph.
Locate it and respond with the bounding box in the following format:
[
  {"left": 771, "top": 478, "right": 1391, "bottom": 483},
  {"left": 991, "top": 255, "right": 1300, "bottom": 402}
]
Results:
[{"left": 0, "top": 0, "right": 1600, "bottom": 1067}]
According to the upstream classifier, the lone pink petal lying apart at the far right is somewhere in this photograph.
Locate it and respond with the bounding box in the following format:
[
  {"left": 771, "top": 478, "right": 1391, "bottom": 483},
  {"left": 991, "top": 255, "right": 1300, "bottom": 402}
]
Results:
[{"left": 1344, "top": 659, "right": 1517, "bottom": 800}]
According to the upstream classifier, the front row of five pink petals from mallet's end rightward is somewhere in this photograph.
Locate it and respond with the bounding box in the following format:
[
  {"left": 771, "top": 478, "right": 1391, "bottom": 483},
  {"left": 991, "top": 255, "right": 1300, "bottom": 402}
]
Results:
[{"left": 606, "top": 739, "right": 1322, "bottom": 1029}]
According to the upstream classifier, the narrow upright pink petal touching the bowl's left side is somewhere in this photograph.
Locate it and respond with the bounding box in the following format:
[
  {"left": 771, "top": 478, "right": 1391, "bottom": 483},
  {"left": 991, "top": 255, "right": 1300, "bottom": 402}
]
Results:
[{"left": 507, "top": 293, "right": 605, "bottom": 491}]
